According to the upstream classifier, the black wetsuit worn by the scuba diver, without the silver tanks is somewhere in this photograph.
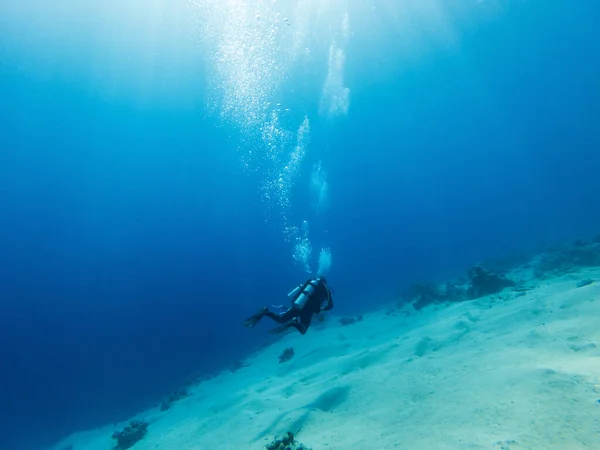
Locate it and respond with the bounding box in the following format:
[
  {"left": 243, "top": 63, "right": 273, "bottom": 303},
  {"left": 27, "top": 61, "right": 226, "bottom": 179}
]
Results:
[{"left": 248, "top": 279, "right": 333, "bottom": 334}]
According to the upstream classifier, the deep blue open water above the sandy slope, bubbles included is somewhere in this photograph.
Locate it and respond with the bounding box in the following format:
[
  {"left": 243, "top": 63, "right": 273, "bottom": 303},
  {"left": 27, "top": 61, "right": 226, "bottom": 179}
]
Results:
[{"left": 0, "top": 0, "right": 600, "bottom": 450}]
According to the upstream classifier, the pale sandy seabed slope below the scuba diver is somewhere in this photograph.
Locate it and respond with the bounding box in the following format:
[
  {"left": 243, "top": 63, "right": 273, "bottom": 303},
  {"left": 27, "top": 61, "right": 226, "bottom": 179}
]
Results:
[{"left": 57, "top": 269, "right": 600, "bottom": 450}]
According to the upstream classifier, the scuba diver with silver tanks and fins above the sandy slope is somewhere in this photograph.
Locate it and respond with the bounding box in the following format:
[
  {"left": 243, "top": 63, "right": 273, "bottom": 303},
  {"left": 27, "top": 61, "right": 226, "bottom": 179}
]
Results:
[{"left": 244, "top": 277, "right": 333, "bottom": 334}]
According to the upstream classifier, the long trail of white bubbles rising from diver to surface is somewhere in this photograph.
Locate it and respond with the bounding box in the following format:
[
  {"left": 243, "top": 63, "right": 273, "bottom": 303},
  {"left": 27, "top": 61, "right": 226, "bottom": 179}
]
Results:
[{"left": 189, "top": 0, "right": 349, "bottom": 271}]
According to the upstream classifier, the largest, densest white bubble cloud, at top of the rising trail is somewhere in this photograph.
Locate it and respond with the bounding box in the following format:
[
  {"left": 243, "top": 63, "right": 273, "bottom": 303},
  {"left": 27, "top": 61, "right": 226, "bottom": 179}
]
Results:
[{"left": 191, "top": 0, "right": 284, "bottom": 133}]
